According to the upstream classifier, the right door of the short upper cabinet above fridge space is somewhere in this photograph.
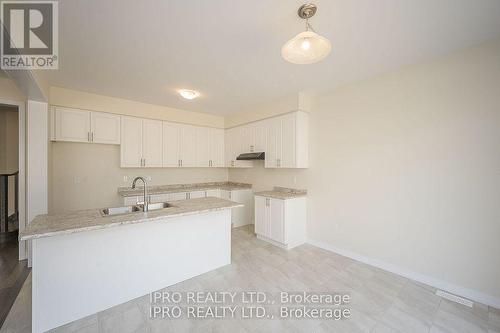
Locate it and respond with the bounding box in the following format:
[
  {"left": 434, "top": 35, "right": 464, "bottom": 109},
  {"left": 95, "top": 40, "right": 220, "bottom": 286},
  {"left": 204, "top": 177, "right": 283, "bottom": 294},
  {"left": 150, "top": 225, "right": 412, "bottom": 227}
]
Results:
[{"left": 90, "top": 112, "right": 121, "bottom": 145}]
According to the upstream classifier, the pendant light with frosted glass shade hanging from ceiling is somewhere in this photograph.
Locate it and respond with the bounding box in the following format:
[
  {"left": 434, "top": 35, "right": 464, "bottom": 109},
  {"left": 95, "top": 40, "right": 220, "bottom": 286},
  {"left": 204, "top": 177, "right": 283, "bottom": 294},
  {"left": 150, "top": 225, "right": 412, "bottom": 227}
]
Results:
[{"left": 281, "top": 4, "right": 332, "bottom": 64}]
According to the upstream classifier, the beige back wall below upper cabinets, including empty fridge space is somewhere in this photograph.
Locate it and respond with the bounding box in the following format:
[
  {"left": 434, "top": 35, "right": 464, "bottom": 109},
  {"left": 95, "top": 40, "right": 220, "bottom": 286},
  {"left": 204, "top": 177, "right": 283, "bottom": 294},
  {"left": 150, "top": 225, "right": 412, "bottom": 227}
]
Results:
[{"left": 49, "top": 142, "right": 227, "bottom": 213}]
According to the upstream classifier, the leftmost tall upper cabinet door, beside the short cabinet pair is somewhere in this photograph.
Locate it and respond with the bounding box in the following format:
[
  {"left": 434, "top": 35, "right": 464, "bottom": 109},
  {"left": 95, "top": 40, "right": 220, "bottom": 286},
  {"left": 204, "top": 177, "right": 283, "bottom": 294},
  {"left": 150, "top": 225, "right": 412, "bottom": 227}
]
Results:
[{"left": 120, "top": 117, "right": 142, "bottom": 168}]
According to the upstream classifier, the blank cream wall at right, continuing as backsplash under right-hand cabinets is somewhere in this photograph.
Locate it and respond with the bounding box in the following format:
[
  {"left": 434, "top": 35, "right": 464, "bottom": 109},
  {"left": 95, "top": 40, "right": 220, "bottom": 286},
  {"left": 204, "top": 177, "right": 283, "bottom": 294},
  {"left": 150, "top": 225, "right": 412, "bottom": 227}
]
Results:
[{"left": 229, "top": 40, "right": 500, "bottom": 307}]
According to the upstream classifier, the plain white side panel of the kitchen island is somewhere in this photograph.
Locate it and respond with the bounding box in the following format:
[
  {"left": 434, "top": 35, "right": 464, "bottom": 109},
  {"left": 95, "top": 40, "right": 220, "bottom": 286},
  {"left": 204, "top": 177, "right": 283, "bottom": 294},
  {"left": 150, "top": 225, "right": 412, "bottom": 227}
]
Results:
[{"left": 32, "top": 209, "right": 231, "bottom": 332}]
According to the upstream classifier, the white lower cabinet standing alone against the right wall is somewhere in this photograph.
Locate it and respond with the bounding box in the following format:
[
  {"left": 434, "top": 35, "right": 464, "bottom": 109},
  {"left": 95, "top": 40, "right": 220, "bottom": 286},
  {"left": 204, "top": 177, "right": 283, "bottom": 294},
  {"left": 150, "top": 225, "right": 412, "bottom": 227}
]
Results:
[{"left": 255, "top": 196, "right": 307, "bottom": 249}]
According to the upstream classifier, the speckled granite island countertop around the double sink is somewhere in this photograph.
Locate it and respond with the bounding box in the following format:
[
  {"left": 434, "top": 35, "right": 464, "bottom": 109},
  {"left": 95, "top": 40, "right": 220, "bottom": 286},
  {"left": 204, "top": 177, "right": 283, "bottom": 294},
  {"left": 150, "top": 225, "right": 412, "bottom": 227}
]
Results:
[{"left": 19, "top": 197, "right": 243, "bottom": 240}]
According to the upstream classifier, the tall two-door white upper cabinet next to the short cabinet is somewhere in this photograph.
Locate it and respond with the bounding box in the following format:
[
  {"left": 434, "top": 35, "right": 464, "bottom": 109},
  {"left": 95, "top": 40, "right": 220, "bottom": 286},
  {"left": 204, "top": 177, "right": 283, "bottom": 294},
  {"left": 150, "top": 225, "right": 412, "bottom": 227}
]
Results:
[{"left": 120, "top": 117, "right": 163, "bottom": 168}]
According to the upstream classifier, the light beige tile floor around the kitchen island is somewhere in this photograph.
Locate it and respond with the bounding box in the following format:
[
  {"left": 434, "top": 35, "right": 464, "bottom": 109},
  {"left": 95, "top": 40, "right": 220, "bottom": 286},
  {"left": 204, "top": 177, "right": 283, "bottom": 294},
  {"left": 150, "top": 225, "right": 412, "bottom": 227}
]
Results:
[{"left": 1, "top": 226, "right": 500, "bottom": 333}]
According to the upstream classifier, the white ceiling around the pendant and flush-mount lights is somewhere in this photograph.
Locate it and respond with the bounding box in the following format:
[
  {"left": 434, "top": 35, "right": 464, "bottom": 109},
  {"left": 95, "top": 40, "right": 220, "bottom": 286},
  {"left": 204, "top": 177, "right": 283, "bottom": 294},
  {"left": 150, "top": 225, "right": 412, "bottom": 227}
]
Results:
[{"left": 50, "top": 0, "right": 500, "bottom": 115}]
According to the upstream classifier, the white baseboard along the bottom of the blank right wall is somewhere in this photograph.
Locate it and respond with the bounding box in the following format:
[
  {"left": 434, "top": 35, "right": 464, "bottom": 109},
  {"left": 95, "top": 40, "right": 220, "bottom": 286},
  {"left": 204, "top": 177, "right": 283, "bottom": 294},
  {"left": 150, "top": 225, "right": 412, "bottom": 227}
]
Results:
[{"left": 307, "top": 239, "right": 500, "bottom": 309}]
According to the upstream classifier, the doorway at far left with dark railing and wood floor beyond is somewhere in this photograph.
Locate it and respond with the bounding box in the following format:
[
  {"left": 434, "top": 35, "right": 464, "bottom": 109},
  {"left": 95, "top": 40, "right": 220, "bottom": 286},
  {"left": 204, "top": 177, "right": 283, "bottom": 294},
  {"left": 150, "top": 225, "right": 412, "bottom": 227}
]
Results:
[{"left": 0, "top": 102, "right": 30, "bottom": 327}]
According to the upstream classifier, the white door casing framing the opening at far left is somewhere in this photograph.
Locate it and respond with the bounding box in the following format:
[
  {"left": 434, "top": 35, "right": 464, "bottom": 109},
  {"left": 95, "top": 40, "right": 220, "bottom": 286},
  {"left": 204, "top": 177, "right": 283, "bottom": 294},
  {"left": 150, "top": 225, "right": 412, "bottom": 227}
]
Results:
[{"left": 0, "top": 98, "right": 27, "bottom": 260}]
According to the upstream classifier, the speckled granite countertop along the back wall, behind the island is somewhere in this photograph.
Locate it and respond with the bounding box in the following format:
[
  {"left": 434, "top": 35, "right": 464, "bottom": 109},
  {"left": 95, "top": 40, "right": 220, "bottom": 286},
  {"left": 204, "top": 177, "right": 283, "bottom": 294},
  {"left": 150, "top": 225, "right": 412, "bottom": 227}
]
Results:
[{"left": 118, "top": 182, "right": 252, "bottom": 197}]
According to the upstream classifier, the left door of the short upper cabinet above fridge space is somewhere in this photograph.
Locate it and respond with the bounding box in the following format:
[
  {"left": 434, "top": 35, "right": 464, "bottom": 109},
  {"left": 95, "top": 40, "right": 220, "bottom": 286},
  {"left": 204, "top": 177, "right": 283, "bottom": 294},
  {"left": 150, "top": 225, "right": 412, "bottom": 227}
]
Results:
[{"left": 55, "top": 107, "right": 90, "bottom": 142}]
